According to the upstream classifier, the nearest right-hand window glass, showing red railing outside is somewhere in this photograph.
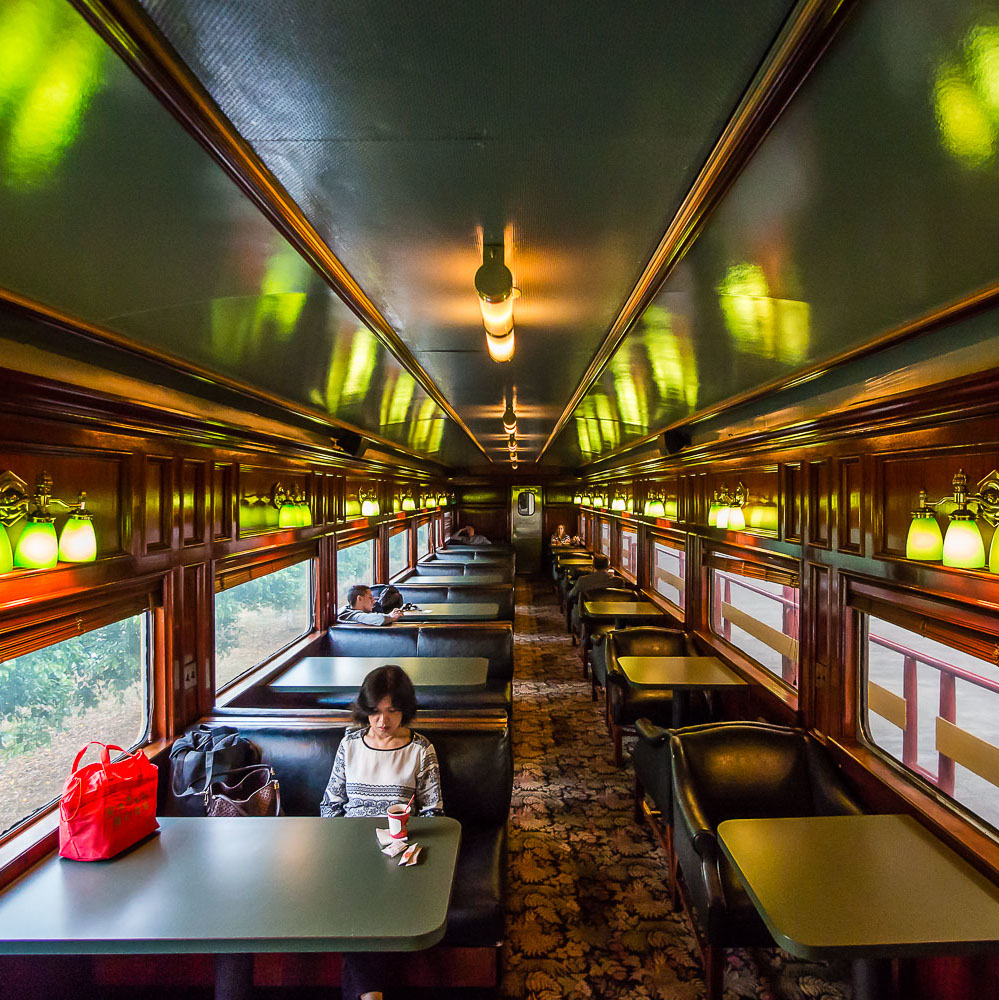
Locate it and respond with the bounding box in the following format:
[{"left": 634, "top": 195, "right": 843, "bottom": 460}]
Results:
[{"left": 861, "top": 615, "right": 999, "bottom": 828}]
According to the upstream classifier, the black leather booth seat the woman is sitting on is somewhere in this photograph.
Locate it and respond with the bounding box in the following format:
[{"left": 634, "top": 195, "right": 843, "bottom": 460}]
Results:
[{"left": 154, "top": 712, "right": 513, "bottom": 949}]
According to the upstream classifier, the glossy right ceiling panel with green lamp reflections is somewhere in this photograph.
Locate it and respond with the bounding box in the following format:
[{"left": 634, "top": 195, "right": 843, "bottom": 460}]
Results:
[{"left": 545, "top": 0, "right": 999, "bottom": 465}]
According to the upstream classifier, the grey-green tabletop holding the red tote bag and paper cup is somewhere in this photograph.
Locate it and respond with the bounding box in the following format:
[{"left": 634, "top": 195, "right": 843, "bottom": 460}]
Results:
[{"left": 0, "top": 816, "right": 461, "bottom": 955}]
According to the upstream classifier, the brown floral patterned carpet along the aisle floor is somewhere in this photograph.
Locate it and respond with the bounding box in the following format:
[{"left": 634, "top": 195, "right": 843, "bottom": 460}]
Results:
[{"left": 502, "top": 578, "right": 850, "bottom": 1000}]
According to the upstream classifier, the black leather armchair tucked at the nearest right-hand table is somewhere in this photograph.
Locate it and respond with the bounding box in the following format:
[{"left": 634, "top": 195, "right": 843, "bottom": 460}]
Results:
[{"left": 670, "top": 722, "right": 863, "bottom": 1000}]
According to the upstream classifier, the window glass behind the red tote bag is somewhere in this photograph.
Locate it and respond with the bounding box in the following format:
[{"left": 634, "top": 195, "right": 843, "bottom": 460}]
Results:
[{"left": 0, "top": 611, "right": 150, "bottom": 834}]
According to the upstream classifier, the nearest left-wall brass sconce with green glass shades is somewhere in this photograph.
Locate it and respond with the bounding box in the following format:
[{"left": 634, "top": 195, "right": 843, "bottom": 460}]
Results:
[{"left": 0, "top": 470, "right": 97, "bottom": 573}]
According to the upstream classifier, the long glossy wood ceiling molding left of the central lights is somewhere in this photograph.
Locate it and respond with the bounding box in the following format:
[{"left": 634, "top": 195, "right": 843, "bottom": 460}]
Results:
[{"left": 63, "top": 0, "right": 492, "bottom": 463}]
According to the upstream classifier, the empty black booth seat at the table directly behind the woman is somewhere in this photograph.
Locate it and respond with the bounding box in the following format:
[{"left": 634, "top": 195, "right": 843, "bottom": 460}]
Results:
[{"left": 229, "top": 622, "right": 513, "bottom": 715}]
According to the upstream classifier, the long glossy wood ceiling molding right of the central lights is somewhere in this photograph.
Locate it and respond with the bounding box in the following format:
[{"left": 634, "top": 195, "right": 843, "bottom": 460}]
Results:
[{"left": 536, "top": 0, "right": 853, "bottom": 461}]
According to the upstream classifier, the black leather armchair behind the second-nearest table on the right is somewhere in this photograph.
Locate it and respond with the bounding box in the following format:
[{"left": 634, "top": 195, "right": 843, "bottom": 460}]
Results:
[{"left": 593, "top": 625, "right": 708, "bottom": 767}]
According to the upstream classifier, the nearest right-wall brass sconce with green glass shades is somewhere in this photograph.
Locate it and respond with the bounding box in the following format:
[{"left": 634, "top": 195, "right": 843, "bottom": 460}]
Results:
[{"left": 905, "top": 469, "right": 999, "bottom": 573}]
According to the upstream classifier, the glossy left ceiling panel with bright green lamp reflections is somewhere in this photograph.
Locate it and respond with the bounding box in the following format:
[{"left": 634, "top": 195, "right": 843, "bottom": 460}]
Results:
[{"left": 0, "top": 0, "right": 479, "bottom": 465}]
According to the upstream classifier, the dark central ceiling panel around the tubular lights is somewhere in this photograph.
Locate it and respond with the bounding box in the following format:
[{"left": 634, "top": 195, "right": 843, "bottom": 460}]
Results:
[{"left": 143, "top": 0, "right": 791, "bottom": 458}]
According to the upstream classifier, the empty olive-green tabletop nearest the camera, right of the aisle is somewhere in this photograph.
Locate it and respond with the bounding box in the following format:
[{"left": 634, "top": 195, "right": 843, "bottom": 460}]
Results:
[{"left": 718, "top": 815, "right": 999, "bottom": 959}]
